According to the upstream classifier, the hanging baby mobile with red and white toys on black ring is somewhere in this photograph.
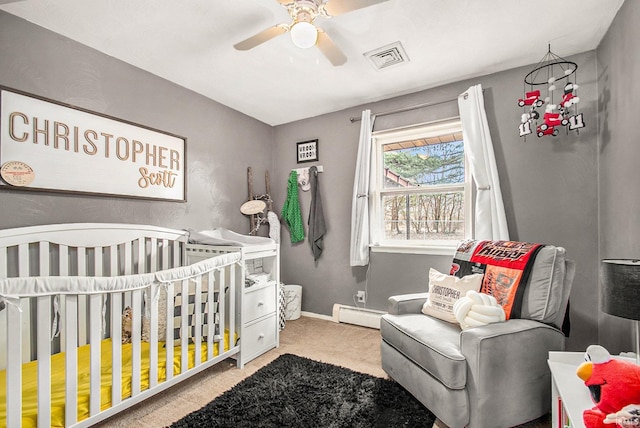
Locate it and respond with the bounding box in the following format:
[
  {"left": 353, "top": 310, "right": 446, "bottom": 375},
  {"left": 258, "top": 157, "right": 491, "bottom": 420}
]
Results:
[{"left": 518, "top": 45, "right": 584, "bottom": 140}]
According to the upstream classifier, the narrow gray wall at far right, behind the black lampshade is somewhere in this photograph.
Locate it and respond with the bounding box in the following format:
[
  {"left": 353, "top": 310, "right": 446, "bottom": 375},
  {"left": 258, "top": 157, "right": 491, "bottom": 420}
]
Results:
[{"left": 598, "top": 1, "right": 640, "bottom": 351}]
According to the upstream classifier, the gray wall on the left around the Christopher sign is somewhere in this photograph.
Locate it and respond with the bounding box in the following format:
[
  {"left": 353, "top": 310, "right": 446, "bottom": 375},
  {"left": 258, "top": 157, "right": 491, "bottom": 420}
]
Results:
[{"left": 0, "top": 11, "right": 274, "bottom": 233}]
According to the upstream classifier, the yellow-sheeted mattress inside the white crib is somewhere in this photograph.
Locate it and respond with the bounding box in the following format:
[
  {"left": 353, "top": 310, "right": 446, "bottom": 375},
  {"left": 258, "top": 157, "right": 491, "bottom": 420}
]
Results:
[{"left": 0, "top": 332, "right": 229, "bottom": 428}]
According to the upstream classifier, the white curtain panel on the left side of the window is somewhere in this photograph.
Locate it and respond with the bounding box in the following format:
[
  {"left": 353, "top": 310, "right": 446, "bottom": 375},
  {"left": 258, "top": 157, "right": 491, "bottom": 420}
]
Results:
[{"left": 350, "top": 110, "right": 375, "bottom": 266}]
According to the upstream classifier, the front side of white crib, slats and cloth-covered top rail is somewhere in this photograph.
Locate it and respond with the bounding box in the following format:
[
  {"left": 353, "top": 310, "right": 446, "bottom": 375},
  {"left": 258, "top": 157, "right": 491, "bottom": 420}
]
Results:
[{"left": 0, "top": 252, "right": 240, "bottom": 427}]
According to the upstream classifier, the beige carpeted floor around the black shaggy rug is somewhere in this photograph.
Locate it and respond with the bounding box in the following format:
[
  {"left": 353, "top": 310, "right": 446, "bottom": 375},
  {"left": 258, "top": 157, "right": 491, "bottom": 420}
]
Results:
[{"left": 98, "top": 317, "right": 551, "bottom": 428}]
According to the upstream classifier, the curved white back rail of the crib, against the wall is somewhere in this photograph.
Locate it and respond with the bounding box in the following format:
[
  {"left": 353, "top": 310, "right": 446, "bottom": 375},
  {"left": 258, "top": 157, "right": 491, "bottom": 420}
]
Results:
[{"left": 0, "top": 223, "right": 188, "bottom": 369}]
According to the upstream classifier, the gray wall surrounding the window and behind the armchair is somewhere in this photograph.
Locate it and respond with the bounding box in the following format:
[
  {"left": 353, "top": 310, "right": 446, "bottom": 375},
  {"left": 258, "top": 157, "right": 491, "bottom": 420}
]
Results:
[{"left": 274, "top": 51, "right": 598, "bottom": 349}]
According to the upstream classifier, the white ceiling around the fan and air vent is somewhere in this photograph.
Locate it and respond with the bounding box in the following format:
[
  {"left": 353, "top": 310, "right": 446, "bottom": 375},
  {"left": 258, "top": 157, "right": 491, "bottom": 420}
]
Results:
[{"left": 0, "top": 0, "right": 623, "bottom": 125}]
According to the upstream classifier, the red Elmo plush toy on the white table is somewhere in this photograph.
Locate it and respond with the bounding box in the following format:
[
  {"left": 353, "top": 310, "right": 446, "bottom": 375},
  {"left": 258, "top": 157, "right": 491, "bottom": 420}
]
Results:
[{"left": 577, "top": 345, "right": 640, "bottom": 428}]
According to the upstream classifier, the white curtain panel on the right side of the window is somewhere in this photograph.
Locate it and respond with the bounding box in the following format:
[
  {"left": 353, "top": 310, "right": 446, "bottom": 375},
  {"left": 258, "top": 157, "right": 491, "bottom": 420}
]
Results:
[{"left": 458, "top": 85, "right": 509, "bottom": 240}]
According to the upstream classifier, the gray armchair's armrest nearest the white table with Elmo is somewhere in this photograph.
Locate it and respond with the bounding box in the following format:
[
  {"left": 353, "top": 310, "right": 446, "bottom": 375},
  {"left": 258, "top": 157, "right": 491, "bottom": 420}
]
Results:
[{"left": 460, "top": 319, "right": 564, "bottom": 426}]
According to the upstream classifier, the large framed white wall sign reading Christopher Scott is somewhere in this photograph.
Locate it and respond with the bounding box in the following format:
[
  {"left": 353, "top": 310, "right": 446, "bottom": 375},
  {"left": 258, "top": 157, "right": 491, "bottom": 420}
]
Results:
[{"left": 0, "top": 86, "right": 187, "bottom": 202}]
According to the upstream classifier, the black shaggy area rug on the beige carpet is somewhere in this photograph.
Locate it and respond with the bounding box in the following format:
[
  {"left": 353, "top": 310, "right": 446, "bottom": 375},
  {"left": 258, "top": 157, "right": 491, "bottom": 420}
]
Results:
[{"left": 171, "top": 354, "right": 435, "bottom": 428}]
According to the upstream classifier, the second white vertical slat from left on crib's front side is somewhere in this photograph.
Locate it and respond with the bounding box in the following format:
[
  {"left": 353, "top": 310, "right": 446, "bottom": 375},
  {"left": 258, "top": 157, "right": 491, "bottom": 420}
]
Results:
[{"left": 36, "top": 296, "right": 51, "bottom": 427}]
